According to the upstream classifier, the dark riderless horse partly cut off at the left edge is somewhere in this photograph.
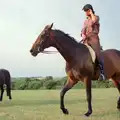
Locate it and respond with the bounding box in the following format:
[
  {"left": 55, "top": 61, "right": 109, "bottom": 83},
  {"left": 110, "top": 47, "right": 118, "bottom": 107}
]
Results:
[{"left": 0, "top": 69, "right": 12, "bottom": 101}]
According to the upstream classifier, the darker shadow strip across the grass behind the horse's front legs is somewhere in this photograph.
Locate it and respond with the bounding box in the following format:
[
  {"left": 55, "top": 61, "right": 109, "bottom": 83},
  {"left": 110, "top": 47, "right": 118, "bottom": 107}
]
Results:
[{"left": 0, "top": 100, "right": 86, "bottom": 107}]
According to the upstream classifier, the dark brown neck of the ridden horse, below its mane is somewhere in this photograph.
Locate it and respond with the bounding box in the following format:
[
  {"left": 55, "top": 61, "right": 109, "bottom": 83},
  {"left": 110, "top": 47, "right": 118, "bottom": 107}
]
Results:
[{"left": 55, "top": 35, "right": 76, "bottom": 62}]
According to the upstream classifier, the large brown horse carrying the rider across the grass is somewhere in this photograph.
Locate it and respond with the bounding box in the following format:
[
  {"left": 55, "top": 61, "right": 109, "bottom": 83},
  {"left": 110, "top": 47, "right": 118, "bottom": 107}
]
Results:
[{"left": 30, "top": 24, "right": 120, "bottom": 116}]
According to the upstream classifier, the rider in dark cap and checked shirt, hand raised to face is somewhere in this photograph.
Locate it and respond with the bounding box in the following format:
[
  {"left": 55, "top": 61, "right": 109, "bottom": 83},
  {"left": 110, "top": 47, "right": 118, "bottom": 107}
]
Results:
[{"left": 81, "top": 4, "right": 106, "bottom": 80}]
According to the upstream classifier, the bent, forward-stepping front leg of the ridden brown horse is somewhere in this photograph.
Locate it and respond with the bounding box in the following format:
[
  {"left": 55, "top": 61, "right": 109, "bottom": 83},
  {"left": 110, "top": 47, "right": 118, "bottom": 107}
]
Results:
[{"left": 60, "top": 78, "right": 76, "bottom": 114}]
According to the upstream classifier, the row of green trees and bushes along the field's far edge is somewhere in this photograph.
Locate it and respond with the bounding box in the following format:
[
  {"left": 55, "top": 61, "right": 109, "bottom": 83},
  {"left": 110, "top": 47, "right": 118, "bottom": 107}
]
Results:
[{"left": 12, "top": 76, "right": 115, "bottom": 90}]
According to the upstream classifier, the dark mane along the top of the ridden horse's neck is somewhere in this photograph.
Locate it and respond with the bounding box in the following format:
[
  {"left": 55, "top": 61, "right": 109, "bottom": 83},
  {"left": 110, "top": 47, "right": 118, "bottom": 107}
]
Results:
[{"left": 53, "top": 29, "right": 78, "bottom": 44}]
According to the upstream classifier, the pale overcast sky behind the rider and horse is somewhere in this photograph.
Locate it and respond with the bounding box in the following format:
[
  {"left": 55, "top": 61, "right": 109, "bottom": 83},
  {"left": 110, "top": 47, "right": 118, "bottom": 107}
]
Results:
[{"left": 0, "top": 0, "right": 120, "bottom": 77}]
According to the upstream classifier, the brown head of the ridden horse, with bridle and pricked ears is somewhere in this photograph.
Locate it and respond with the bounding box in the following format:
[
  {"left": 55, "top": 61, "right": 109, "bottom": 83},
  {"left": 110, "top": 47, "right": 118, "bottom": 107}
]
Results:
[{"left": 30, "top": 23, "right": 53, "bottom": 56}]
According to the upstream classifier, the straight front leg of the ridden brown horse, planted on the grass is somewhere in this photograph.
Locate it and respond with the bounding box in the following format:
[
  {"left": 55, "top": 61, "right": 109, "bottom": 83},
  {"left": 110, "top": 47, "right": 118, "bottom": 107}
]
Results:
[{"left": 84, "top": 78, "right": 92, "bottom": 117}]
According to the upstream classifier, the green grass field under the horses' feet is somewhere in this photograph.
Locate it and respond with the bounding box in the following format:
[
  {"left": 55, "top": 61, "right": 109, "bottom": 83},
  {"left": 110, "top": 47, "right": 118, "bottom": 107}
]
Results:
[{"left": 0, "top": 88, "right": 120, "bottom": 120}]
